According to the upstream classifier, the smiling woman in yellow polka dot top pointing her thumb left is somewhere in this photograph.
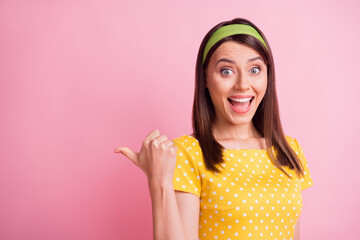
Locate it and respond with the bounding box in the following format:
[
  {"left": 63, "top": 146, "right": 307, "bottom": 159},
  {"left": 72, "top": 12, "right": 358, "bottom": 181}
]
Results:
[{"left": 115, "top": 18, "right": 313, "bottom": 240}]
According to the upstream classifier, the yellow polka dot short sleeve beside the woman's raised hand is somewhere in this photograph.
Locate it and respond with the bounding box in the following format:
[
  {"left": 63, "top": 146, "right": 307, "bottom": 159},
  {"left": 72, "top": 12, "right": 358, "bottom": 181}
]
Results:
[{"left": 173, "top": 139, "right": 201, "bottom": 197}]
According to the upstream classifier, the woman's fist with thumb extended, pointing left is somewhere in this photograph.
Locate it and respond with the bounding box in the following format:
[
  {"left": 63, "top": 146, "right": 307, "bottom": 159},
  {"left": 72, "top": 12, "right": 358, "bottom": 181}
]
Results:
[{"left": 114, "top": 130, "right": 177, "bottom": 185}]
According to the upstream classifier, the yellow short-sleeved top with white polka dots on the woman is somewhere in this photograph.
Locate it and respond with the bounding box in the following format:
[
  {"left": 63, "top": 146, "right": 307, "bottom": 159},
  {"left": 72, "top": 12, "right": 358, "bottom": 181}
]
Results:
[{"left": 173, "top": 135, "right": 313, "bottom": 240}]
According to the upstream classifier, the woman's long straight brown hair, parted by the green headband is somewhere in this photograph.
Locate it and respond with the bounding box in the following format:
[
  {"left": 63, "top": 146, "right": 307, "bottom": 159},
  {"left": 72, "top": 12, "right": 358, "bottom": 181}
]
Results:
[{"left": 192, "top": 18, "right": 304, "bottom": 177}]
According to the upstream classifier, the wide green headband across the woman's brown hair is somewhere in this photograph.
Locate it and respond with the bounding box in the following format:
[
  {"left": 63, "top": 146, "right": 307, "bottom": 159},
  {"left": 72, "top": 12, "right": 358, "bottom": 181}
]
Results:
[{"left": 203, "top": 24, "right": 266, "bottom": 64}]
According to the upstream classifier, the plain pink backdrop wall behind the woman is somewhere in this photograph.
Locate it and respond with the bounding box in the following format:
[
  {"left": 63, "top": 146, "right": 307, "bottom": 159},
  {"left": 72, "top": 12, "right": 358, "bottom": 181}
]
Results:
[{"left": 0, "top": 0, "right": 360, "bottom": 240}]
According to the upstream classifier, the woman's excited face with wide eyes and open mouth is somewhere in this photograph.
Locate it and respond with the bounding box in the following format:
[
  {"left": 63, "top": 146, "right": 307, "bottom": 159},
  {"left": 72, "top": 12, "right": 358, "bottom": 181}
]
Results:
[{"left": 206, "top": 41, "right": 267, "bottom": 127}]
